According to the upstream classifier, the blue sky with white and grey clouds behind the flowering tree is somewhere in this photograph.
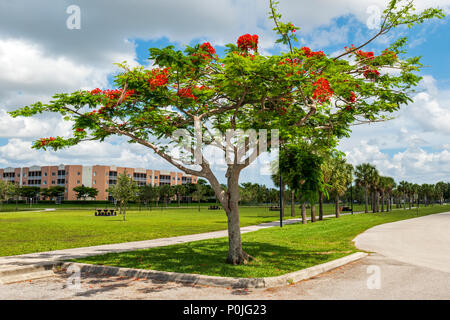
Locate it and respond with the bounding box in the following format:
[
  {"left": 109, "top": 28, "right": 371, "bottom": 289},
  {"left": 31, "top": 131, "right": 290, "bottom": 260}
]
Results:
[{"left": 0, "top": 0, "right": 450, "bottom": 184}]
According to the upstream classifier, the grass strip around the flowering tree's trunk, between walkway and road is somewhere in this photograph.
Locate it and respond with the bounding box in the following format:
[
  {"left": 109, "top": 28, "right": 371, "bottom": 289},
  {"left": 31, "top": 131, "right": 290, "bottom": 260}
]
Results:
[{"left": 75, "top": 205, "right": 450, "bottom": 277}]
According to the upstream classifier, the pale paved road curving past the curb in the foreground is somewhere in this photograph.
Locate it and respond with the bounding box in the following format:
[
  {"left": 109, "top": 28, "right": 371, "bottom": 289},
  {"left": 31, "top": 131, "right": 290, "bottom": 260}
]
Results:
[{"left": 0, "top": 213, "right": 450, "bottom": 299}]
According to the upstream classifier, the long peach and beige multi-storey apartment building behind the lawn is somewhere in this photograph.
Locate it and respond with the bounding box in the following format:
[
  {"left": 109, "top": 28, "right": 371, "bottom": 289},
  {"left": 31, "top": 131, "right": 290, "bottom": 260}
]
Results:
[{"left": 0, "top": 164, "right": 197, "bottom": 200}]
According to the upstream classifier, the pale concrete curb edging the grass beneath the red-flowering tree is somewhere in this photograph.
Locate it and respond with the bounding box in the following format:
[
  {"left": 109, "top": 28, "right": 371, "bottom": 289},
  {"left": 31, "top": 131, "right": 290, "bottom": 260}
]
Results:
[{"left": 59, "top": 252, "right": 368, "bottom": 288}]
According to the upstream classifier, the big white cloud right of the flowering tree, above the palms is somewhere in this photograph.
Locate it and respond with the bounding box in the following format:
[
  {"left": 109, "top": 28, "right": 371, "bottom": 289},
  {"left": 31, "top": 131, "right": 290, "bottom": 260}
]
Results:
[{"left": 340, "top": 76, "right": 450, "bottom": 183}]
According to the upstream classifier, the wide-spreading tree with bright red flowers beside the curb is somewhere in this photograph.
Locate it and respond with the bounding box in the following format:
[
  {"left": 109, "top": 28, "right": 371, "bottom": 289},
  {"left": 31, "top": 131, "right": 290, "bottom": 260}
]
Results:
[{"left": 10, "top": 0, "right": 443, "bottom": 264}]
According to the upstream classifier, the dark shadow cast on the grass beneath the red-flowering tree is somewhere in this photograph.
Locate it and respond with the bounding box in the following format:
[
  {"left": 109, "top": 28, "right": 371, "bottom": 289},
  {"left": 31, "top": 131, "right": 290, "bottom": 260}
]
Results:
[{"left": 76, "top": 239, "right": 345, "bottom": 278}]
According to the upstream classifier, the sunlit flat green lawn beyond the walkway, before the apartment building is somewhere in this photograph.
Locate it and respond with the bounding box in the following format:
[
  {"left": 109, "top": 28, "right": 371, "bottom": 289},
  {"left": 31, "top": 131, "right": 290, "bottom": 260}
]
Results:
[{"left": 0, "top": 208, "right": 279, "bottom": 256}]
